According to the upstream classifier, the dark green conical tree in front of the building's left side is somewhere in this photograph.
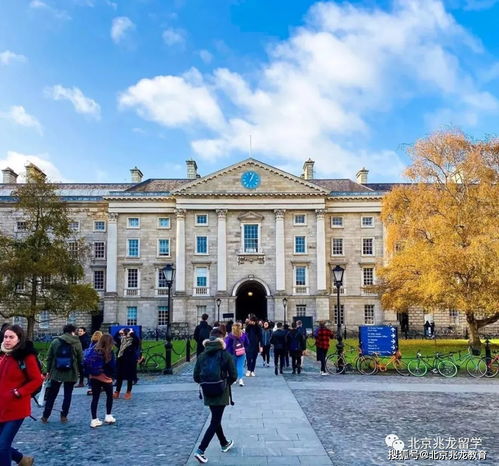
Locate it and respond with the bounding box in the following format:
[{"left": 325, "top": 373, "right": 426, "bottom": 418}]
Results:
[{"left": 0, "top": 173, "right": 99, "bottom": 338}]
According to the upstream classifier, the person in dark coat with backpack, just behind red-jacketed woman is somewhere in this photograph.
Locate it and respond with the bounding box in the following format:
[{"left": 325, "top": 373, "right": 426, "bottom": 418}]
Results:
[{"left": 40, "top": 324, "right": 83, "bottom": 424}]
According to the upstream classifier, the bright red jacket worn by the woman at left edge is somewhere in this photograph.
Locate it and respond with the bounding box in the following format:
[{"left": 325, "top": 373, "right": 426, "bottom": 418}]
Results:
[{"left": 0, "top": 354, "right": 43, "bottom": 422}]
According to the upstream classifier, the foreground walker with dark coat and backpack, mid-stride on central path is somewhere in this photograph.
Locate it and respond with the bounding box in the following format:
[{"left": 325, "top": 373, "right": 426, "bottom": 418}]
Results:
[{"left": 194, "top": 329, "right": 237, "bottom": 463}]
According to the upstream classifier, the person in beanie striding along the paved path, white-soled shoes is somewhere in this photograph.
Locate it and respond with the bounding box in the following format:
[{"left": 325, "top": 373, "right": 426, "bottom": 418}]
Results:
[{"left": 194, "top": 329, "right": 237, "bottom": 463}]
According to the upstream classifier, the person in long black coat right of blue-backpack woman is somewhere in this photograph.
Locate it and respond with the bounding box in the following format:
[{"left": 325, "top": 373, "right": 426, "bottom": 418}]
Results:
[{"left": 112, "top": 328, "right": 139, "bottom": 400}]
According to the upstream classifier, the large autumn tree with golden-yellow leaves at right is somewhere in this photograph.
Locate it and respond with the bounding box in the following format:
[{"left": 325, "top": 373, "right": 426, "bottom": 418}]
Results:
[{"left": 376, "top": 131, "right": 499, "bottom": 348}]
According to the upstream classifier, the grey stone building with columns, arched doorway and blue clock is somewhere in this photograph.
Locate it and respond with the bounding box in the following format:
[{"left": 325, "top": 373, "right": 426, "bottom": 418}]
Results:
[{"left": 0, "top": 158, "right": 476, "bottom": 330}]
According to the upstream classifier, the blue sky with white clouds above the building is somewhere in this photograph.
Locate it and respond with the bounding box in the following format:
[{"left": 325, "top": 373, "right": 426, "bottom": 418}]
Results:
[{"left": 0, "top": 0, "right": 499, "bottom": 182}]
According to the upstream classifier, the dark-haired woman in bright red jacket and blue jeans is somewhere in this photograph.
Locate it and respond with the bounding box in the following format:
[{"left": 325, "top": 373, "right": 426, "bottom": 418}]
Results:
[{"left": 0, "top": 325, "right": 43, "bottom": 466}]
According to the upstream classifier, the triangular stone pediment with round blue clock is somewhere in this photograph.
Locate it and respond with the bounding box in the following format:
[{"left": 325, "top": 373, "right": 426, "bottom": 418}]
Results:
[{"left": 172, "top": 158, "right": 329, "bottom": 196}]
